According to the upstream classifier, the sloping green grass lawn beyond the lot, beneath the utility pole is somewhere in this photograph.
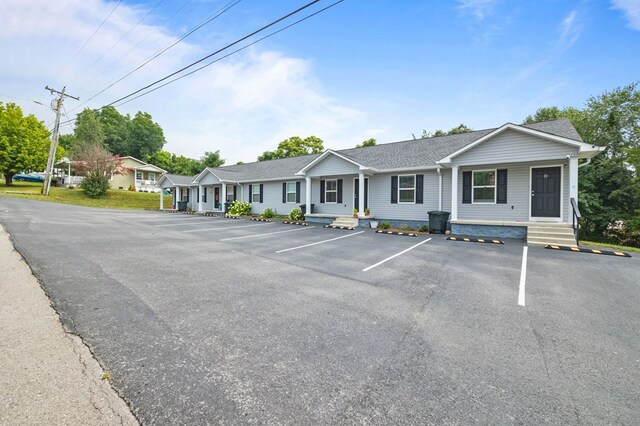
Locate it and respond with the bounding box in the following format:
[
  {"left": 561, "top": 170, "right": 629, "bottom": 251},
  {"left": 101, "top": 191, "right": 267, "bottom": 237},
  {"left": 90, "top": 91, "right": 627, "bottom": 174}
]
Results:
[{"left": 0, "top": 179, "right": 171, "bottom": 209}]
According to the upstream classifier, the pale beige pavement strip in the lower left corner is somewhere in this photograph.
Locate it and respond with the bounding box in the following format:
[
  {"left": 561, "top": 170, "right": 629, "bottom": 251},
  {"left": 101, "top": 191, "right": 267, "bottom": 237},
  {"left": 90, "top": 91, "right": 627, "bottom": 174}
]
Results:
[{"left": 0, "top": 227, "right": 138, "bottom": 425}]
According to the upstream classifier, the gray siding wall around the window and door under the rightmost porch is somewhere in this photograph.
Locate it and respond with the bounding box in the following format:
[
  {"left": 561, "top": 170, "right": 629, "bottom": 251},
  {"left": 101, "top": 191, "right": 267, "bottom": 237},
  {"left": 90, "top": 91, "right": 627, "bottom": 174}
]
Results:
[{"left": 458, "top": 161, "right": 570, "bottom": 222}]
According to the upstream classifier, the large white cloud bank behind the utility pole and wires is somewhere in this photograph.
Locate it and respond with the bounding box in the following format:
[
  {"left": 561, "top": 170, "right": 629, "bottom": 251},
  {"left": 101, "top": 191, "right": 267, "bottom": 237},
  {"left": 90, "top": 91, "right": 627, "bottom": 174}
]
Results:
[{"left": 0, "top": 0, "right": 370, "bottom": 164}]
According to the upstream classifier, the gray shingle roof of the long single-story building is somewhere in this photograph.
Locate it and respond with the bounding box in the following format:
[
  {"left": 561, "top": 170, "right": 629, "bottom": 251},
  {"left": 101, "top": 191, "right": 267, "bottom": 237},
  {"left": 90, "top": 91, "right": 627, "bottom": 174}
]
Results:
[{"left": 188, "top": 119, "right": 582, "bottom": 182}]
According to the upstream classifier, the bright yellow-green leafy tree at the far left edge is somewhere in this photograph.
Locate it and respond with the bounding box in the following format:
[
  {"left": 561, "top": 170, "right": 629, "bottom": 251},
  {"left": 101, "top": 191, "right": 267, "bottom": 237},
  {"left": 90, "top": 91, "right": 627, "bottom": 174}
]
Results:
[{"left": 0, "top": 102, "right": 53, "bottom": 185}]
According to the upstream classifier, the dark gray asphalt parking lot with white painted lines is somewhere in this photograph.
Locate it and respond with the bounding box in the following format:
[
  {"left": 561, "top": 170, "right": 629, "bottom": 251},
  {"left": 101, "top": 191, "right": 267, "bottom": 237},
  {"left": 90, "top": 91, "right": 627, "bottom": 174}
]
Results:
[{"left": 0, "top": 198, "right": 640, "bottom": 424}]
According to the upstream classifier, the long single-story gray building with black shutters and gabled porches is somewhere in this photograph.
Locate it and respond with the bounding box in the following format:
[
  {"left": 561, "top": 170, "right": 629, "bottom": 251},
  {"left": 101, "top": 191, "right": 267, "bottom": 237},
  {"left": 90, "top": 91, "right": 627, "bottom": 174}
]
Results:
[{"left": 156, "top": 119, "right": 603, "bottom": 246}]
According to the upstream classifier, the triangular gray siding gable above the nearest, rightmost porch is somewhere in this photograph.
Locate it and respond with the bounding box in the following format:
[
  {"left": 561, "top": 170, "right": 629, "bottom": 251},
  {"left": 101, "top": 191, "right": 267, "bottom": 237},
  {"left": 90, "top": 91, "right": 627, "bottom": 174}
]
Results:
[{"left": 452, "top": 130, "right": 578, "bottom": 166}]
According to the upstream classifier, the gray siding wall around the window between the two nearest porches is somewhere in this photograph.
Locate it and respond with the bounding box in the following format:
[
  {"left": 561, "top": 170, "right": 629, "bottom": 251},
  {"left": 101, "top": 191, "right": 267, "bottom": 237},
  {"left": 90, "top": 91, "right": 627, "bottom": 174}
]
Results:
[{"left": 369, "top": 170, "right": 440, "bottom": 220}]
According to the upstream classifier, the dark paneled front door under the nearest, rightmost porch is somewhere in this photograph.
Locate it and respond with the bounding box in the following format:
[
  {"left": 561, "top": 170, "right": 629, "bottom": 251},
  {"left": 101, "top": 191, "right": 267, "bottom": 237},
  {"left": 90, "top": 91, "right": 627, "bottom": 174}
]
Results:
[{"left": 531, "top": 167, "right": 561, "bottom": 218}]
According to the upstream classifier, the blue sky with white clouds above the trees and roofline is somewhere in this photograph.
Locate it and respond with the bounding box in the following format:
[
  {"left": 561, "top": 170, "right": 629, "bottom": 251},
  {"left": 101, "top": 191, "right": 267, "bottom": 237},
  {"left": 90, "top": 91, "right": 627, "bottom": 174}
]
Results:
[{"left": 0, "top": 0, "right": 640, "bottom": 164}]
